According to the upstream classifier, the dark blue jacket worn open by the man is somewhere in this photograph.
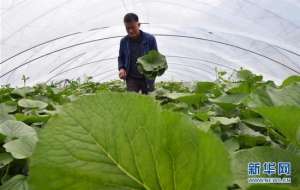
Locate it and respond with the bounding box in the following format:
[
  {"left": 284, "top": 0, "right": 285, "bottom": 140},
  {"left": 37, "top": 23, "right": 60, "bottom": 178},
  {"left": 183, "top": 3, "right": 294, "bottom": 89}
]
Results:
[{"left": 118, "top": 30, "right": 158, "bottom": 83}]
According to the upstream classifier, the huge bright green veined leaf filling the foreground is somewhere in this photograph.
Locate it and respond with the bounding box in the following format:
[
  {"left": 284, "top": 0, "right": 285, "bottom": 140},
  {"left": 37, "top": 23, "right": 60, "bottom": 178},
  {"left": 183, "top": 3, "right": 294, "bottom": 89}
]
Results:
[{"left": 29, "top": 93, "right": 231, "bottom": 190}]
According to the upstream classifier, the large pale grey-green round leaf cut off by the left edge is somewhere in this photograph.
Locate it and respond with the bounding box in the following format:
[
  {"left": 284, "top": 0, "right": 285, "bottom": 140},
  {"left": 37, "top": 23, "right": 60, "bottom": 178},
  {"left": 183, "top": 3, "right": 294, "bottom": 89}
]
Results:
[{"left": 0, "top": 120, "right": 37, "bottom": 159}]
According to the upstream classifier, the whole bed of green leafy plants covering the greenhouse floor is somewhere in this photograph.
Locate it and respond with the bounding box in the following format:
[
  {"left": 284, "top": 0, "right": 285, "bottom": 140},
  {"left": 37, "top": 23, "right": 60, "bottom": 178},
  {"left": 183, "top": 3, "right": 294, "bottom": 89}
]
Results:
[{"left": 0, "top": 70, "right": 300, "bottom": 190}]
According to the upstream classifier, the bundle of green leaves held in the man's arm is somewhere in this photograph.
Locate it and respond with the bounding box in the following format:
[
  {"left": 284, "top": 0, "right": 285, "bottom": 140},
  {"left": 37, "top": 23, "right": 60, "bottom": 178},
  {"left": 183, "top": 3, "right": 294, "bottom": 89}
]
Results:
[{"left": 137, "top": 50, "right": 168, "bottom": 79}]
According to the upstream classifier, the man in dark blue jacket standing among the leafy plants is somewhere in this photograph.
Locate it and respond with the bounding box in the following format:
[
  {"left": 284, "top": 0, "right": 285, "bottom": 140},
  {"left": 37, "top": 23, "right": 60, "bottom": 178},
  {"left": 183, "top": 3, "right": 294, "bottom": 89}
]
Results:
[{"left": 118, "top": 13, "right": 157, "bottom": 94}]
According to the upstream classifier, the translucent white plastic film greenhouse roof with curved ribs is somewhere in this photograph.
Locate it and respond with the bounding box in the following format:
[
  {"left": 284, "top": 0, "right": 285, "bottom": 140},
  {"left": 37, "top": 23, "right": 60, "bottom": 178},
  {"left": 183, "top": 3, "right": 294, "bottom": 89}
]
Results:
[{"left": 0, "top": 0, "right": 300, "bottom": 85}]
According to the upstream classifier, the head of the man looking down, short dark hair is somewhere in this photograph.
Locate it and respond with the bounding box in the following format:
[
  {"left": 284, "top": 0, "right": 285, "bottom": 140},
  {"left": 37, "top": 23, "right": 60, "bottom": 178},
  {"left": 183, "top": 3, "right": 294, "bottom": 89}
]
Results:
[{"left": 124, "top": 13, "right": 141, "bottom": 38}]
